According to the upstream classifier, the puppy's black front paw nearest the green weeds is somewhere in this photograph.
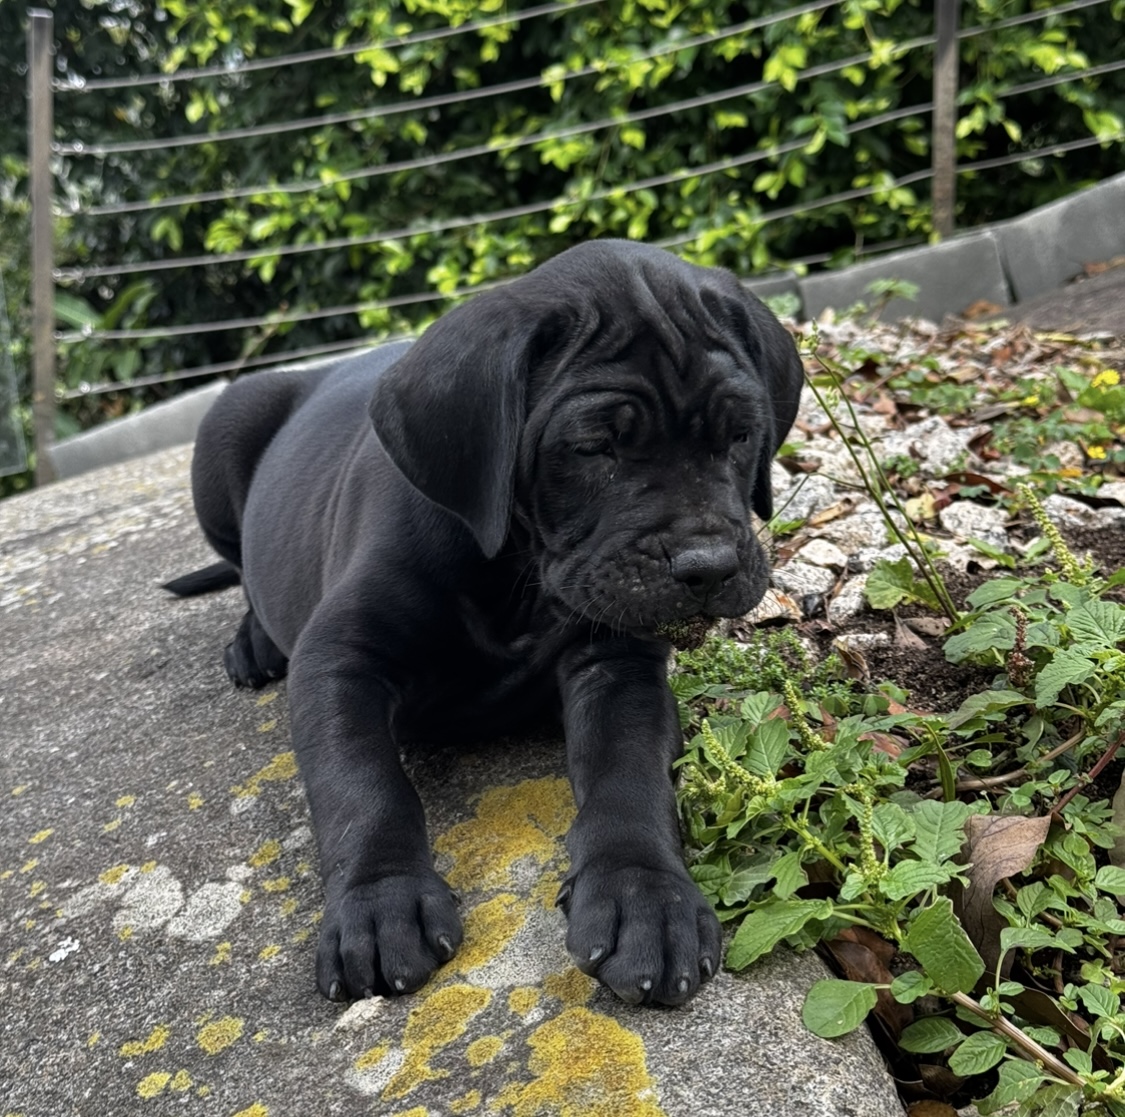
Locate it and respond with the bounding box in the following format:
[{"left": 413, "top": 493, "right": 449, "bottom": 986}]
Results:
[{"left": 558, "top": 868, "right": 722, "bottom": 1005}]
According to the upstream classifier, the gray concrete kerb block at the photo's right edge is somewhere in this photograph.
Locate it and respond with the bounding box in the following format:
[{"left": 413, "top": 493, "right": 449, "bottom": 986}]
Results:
[{"left": 997, "top": 173, "right": 1125, "bottom": 301}]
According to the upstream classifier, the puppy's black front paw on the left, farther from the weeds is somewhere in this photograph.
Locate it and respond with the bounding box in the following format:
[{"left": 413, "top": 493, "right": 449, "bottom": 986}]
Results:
[{"left": 316, "top": 873, "right": 461, "bottom": 1001}]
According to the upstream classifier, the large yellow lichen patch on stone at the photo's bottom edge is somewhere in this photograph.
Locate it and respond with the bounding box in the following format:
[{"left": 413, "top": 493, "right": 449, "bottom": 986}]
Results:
[{"left": 493, "top": 1008, "right": 666, "bottom": 1117}]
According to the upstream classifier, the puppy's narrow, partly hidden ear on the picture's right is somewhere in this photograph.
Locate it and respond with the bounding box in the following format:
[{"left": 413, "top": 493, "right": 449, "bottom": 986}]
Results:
[{"left": 709, "top": 280, "right": 804, "bottom": 522}]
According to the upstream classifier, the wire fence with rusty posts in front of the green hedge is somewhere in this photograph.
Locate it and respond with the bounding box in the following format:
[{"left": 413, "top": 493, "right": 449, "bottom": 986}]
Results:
[{"left": 15, "top": 0, "right": 1125, "bottom": 480}]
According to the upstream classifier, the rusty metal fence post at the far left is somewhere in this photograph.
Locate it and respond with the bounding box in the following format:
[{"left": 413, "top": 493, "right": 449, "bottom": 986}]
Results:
[{"left": 27, "top": 8, "right": 55, "bottom": 485}]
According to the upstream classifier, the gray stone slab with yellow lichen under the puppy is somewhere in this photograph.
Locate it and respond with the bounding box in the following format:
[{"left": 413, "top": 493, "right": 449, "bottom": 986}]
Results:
[{"left": 0, "top": 448, "right": 901, "bottom": 1117}]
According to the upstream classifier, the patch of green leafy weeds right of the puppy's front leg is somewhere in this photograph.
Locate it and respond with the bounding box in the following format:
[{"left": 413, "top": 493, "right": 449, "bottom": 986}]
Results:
[{"left": 673, "top": 335, "right": 1125, "bottom": 1117}]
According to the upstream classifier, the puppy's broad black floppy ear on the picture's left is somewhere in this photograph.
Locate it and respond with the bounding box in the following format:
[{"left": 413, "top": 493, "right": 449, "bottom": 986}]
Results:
[{"left": 370, "top": 290, "right": 539, "bottom": 558}]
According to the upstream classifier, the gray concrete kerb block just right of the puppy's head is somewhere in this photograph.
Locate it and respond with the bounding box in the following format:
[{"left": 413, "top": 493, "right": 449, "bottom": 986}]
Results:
[{"left": 798, "top": 229, "right": 1010, "bottom": 322}]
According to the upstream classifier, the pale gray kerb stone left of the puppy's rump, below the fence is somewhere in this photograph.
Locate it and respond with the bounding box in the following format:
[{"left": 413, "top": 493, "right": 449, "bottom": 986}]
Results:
[{"left": 50, "top": 380, "right": 227, "bottom": 477}]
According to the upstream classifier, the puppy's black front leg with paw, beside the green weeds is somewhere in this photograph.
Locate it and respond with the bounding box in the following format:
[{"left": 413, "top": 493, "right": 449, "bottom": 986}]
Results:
[{"left": 559, "top": 637, "right": 722, "bottom": 1005}]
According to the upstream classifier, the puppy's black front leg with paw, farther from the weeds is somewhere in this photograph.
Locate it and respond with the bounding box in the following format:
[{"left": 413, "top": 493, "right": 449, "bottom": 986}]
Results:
[{"left": 289, "top": 616, "right": 461, "bottom": 1000}]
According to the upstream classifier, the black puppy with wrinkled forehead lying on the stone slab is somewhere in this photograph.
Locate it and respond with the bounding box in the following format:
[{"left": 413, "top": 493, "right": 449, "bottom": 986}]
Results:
[{"left": 168, "top": 241, "right": 801, "bottom": 1005}]
